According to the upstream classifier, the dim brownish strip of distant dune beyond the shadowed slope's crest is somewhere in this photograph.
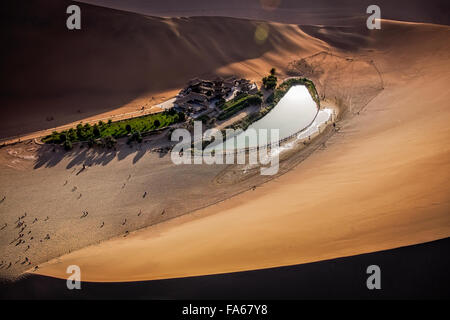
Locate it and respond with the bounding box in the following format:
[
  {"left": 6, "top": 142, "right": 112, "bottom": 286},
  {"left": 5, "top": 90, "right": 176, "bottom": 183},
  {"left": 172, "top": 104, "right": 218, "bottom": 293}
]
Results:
[{"left": 80, "top": 0, "right": 450, "bottom": 25}]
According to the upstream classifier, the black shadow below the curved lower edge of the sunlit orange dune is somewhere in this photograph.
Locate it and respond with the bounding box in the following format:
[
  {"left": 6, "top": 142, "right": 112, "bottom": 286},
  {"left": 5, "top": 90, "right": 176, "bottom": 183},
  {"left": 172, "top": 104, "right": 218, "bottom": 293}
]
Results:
[{"left": 0, "top": 238, "right": 450, "bottom": 299}]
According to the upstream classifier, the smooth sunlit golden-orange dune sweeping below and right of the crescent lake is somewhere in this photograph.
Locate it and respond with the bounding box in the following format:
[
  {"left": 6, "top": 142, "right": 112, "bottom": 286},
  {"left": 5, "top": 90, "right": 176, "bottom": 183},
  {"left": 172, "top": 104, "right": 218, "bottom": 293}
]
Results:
[{"left": 32, "top": 20, "right": 450, "bottom": 281}]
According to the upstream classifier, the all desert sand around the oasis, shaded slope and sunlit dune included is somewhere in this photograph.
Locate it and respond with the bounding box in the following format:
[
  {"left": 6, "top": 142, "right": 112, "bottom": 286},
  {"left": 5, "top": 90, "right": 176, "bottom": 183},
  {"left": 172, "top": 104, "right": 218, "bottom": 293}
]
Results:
[{"left": 0, "top": 1, "right": 450, "bottom": 281}]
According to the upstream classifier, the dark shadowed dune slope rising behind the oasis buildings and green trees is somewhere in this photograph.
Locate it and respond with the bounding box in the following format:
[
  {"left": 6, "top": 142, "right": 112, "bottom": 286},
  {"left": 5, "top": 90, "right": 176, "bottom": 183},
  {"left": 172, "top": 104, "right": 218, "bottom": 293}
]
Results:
[{"left": 0, "top": 0, "right": 320, "bottom": 138}]
